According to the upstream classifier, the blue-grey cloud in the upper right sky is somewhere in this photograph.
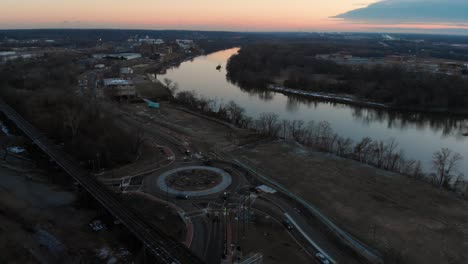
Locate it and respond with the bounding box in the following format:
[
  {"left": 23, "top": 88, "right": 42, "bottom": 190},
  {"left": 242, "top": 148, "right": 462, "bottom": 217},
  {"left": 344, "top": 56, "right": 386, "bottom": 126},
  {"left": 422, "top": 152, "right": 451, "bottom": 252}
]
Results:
[{"left": 334, "top": 0, "right": 468, "bottom": 25}]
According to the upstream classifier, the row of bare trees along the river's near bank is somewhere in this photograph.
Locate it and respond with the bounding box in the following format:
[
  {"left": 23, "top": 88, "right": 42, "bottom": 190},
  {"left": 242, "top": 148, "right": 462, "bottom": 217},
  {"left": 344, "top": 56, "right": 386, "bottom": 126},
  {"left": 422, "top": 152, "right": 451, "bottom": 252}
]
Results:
[{"left": 175, "top": 91, "right": 468, "bottom": 196}]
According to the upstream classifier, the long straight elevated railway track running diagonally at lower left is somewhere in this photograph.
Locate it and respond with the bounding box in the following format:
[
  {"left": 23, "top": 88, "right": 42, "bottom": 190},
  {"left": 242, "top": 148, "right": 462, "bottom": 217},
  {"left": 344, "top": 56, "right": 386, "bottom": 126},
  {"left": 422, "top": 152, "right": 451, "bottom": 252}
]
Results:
[{"left": 0, "top": 99, "right": 203, "bottom": 264}]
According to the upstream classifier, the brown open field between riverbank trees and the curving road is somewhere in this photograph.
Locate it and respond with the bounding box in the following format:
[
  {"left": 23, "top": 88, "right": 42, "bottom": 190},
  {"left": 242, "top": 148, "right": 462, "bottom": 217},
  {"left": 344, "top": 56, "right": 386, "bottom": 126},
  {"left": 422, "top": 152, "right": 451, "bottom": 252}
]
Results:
[{"left": 237, "top": 142, "right": 468, "bottom": 264}]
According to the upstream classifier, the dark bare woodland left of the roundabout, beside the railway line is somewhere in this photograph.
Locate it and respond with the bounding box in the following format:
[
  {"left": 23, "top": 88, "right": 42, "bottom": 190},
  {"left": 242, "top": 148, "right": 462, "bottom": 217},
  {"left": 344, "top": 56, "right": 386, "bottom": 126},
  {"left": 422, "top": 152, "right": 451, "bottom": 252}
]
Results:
[{"left": 0, "top": 53, "right": 139, "bottom": 171}]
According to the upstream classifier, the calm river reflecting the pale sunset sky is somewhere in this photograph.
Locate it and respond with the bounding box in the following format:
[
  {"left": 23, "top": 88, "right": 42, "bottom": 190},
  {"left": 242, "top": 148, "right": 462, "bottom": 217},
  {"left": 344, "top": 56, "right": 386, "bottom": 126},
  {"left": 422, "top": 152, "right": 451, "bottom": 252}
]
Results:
[{"left": 158, "top": 48, "right": 468, "bottom": 179}]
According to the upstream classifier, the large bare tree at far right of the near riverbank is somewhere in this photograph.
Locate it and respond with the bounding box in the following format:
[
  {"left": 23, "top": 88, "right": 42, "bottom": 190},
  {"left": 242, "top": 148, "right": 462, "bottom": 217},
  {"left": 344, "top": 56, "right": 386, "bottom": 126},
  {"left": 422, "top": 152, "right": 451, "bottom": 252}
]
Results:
[{"left": 432, "top": 148, "right": 463, "bottom": 187}]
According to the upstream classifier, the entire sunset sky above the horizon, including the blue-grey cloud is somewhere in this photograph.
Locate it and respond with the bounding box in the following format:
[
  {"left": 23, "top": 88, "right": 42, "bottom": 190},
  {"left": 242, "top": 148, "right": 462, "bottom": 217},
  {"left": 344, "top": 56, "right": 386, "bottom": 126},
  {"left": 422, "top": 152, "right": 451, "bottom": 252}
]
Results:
[{"left": 0, "top": 0, "right": 468, "bottom": 34}]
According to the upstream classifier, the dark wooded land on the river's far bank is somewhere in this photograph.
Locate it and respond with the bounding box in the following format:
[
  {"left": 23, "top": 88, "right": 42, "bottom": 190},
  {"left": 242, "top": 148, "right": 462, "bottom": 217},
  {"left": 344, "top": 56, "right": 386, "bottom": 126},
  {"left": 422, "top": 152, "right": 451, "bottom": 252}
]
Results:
[{"left": 227, "top": 44, "right": 468, "bottom": 111}]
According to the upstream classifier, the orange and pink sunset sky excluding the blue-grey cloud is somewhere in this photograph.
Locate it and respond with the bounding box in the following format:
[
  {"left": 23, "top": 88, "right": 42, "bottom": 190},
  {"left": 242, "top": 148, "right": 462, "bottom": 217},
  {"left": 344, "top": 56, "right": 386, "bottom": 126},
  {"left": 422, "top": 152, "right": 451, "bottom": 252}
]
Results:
[{"left": 0, "top": 0, "right": 468, "bottom": 31}]
